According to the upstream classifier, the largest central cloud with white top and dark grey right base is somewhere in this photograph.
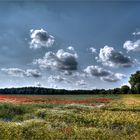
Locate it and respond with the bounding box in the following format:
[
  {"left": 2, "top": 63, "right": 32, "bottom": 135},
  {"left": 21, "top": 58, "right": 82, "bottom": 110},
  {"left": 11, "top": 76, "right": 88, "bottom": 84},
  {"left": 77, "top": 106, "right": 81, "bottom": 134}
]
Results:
[{"left": 33, "top": 49, "right": 78, "bottom": 70}]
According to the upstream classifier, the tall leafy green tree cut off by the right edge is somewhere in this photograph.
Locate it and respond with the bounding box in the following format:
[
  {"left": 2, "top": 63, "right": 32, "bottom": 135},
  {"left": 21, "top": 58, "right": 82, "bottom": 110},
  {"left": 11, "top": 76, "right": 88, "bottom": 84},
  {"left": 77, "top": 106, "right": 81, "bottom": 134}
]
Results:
[{"left": 129, "top": 71, "right": 140, "bottom": 93}]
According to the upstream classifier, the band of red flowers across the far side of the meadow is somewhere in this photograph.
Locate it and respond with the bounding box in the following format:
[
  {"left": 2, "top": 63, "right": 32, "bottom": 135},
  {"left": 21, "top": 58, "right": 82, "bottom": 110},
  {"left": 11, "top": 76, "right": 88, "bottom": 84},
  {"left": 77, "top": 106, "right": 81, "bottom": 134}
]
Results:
[{"left": 0, "top": 95, "right": 117, "bottom": 105}]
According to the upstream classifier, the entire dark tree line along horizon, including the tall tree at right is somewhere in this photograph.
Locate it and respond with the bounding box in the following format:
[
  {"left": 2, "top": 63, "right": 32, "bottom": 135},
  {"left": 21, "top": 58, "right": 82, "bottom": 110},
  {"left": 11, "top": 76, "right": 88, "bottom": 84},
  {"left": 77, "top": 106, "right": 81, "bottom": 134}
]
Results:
[{"left": 0, "top": 71, "right": 140, "bottom": 95}]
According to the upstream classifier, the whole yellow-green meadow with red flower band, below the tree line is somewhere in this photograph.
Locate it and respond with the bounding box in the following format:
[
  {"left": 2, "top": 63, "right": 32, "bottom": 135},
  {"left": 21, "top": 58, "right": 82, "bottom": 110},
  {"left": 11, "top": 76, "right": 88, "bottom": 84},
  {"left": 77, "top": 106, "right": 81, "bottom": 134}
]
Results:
[{"left": 0, "top": 95, "right": 140, "bottom": 140}]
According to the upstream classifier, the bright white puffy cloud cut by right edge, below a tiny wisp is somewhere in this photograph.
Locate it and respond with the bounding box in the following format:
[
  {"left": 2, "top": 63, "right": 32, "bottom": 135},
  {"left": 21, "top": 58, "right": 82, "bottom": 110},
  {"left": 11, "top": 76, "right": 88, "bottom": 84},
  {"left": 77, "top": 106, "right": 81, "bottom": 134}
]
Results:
[{"left": 123, "top": 40, "right": 140, "bottom": 52}]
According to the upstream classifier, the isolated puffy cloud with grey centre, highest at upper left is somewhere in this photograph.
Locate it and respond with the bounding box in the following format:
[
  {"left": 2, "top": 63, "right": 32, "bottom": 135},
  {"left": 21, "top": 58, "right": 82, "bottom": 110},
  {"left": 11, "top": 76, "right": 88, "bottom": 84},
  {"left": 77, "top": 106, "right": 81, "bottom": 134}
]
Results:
[{"left": 30, "top": 29, "right": 54, "bottom": 49}]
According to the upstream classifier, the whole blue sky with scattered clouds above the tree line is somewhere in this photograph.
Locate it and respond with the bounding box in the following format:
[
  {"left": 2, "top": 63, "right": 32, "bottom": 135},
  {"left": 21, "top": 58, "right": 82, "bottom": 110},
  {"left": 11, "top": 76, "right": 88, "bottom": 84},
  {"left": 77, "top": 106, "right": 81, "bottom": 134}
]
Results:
[{"left": 0, "top": 0, "right": 140, "bottom": 90}]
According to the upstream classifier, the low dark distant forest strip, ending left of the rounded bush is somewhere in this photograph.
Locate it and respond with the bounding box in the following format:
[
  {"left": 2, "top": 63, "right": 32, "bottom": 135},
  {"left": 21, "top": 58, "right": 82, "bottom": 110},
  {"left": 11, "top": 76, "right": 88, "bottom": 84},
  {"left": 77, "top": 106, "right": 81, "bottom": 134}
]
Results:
[{"left": 0, "top": 87, "right": 123, "bottom": 95}]
